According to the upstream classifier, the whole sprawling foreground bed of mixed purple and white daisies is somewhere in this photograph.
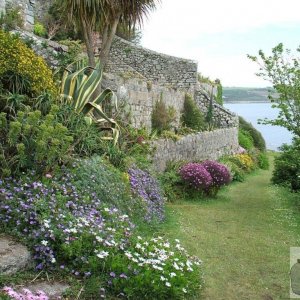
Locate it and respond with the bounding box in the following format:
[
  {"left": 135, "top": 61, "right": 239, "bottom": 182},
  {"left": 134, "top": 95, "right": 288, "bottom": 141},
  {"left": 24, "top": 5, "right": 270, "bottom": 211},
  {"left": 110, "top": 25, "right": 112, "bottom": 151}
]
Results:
[{"left": 0, "top": 174, "right": 202, "bottom": 299}]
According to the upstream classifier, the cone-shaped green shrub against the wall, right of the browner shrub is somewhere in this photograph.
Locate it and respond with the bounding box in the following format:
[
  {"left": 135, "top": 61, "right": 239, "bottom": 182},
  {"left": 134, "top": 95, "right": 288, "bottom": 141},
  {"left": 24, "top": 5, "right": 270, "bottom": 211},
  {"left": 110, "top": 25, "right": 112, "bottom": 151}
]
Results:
[{"left": 182, "top": 94, "right": 206, "bottom": 131}]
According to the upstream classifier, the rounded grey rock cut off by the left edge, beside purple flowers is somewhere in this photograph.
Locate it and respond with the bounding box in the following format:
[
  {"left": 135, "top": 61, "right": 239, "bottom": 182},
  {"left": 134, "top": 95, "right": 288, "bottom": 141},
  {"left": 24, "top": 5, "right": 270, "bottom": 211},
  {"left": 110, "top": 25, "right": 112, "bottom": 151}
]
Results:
[{"left": 0, "top": 236, "right": 31, "bottom": 275}]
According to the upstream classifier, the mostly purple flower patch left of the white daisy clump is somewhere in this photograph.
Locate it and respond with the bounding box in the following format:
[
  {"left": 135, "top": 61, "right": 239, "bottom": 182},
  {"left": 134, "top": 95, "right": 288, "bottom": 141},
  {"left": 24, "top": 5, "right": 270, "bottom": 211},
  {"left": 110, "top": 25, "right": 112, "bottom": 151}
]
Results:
[{"left": 0, "top": 173, "right": 134, "bottom": 274}]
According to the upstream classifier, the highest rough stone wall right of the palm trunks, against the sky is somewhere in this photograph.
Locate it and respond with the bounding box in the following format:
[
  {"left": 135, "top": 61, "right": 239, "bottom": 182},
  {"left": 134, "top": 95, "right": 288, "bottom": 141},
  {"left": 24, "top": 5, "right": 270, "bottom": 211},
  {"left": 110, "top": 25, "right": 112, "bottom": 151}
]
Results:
[{"left": 106, "top": 37, "right": 197, "bottom": 89}]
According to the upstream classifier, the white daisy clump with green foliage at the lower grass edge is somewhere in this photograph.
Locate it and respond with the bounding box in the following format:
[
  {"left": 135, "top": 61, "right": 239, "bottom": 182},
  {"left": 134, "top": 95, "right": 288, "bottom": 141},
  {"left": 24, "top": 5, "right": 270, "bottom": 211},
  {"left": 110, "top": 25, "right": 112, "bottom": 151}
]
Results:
[{"left": 104, "top": 236, "right": 201, "bottom": 299}]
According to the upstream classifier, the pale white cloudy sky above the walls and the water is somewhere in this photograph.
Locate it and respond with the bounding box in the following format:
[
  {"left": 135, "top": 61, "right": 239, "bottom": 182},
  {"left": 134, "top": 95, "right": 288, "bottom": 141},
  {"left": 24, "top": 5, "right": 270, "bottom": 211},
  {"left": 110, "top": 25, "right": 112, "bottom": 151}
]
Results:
[{"left": 141, "top": 0, "right": 300, "bottom": 87}]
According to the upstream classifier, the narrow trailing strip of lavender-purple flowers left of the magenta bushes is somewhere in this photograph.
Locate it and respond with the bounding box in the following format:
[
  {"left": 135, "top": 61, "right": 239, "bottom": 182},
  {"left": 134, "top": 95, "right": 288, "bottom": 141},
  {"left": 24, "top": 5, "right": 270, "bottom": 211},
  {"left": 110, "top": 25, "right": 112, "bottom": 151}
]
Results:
[{"left": 128, "top": 168, "right": 165, "bottom": 222}]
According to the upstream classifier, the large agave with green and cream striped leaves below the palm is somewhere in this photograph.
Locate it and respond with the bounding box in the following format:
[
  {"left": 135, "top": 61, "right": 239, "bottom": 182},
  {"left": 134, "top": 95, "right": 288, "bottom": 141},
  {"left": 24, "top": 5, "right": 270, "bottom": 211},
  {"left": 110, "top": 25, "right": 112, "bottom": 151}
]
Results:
[{"left": 61, "top": 61, "right": 119, "bottom": 144}]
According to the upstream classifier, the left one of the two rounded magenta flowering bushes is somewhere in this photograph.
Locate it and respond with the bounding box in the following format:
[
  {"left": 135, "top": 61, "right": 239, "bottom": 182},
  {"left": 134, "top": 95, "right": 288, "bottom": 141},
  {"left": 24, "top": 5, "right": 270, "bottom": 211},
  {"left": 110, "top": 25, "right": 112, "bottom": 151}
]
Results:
[{"left": 179, "top": 163, "right": 213, "bottom": 190}]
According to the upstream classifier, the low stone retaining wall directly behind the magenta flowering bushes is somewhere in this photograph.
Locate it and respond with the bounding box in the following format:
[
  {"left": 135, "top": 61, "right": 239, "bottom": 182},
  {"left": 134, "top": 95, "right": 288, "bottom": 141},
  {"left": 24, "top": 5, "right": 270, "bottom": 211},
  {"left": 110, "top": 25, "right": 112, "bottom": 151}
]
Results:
[{"left": 152, "top": 127, "right": 239, "bottom": 172}]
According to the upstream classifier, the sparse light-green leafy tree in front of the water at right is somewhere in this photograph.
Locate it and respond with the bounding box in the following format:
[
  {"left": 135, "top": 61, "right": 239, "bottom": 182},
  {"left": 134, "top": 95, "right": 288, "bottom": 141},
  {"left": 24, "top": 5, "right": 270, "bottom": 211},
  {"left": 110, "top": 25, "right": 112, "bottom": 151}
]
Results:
[{"left": 248, "top": 43, "right": 300, "bottom": 138}]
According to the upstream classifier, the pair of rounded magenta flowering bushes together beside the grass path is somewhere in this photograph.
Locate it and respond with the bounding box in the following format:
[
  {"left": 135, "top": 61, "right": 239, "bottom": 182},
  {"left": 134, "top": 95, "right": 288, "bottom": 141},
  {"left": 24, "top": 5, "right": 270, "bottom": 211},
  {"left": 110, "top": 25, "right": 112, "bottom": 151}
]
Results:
[{"left": 179, "top": 160, "right": 231, "bottom": 194}]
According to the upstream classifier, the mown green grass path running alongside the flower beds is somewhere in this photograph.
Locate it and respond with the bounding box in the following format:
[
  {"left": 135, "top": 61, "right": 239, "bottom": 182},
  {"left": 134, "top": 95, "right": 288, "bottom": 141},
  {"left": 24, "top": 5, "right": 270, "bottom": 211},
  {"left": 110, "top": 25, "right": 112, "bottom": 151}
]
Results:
[{"left": 164, "top": 158, "right": 300, "bottom": 300}]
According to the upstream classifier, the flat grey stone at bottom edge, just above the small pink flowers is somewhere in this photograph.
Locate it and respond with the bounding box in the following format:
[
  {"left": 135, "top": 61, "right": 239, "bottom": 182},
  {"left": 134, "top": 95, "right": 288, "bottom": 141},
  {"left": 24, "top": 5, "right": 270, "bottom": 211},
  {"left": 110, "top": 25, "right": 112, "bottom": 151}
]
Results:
[{"left": 24, "top": 281, "right": 69, "bottom": 300}]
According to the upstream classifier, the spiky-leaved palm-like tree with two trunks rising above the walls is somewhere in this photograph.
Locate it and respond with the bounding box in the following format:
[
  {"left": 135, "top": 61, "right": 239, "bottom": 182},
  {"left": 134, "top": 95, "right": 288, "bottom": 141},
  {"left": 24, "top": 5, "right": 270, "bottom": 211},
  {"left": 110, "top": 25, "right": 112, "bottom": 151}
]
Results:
[{"left": 63, "top": 0, "right": 160, "bottom": 68}]
